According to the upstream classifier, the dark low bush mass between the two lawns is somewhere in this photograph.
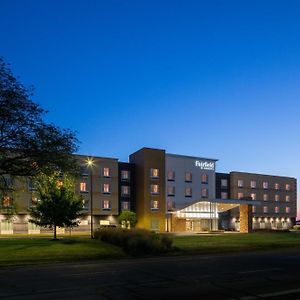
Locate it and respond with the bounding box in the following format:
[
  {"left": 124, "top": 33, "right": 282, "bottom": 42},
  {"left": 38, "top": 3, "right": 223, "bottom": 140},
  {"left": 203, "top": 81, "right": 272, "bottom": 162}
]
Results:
[{"left": 94, "top": 228, "right": 173, "bottom": 256}]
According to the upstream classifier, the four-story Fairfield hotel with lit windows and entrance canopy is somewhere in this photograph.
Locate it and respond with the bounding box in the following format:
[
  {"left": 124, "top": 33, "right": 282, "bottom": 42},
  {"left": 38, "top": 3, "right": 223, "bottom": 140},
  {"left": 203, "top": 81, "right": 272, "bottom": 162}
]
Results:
[{"left": 0, "top": 148, "right": 297, "bottom": 234}]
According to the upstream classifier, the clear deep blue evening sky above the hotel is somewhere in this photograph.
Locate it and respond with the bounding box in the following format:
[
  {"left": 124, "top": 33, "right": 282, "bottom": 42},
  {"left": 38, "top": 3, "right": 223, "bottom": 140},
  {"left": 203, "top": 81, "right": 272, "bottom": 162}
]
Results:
[{"left": 0, "top": 0, "right": 300, "bottom": 216}]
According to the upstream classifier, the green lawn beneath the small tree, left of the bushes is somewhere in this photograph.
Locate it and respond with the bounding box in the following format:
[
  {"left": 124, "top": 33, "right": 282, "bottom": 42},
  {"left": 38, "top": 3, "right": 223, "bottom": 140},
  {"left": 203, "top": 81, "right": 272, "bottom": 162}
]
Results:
[{"left": 0, "top": 237, "right": 125, "bottom": 266}]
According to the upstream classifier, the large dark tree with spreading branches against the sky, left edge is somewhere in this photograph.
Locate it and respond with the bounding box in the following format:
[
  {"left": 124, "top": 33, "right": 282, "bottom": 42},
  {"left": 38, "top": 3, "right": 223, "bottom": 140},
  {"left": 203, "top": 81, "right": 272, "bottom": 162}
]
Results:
[{"left": 0, "top": 58, "right": 78, "bottom": 176}]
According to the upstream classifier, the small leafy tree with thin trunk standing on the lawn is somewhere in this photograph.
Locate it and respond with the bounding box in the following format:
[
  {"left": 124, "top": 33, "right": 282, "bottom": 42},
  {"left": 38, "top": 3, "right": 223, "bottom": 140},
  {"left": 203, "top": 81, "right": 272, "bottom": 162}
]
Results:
[{"left": 29, "top": 172, "right": 83, "bottom": 240}]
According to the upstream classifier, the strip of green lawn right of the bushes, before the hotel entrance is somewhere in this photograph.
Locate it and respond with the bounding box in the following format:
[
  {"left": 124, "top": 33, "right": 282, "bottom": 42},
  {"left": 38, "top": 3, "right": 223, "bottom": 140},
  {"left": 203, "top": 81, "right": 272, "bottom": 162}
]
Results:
[{"left": 174, "top": 232, "right": 300, "bottom": 254}]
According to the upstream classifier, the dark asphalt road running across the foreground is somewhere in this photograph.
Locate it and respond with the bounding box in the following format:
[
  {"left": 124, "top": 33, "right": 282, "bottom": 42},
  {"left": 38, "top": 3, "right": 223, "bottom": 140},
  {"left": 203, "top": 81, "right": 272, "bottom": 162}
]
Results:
[{"left": 0, "top": 250, "right": 300, "bottom": 300}]
